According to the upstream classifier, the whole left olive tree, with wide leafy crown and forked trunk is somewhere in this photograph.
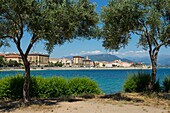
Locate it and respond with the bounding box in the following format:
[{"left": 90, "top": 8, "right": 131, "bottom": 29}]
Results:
[{"left": 0, "top": 0, "right": 98, "bottom": 103}]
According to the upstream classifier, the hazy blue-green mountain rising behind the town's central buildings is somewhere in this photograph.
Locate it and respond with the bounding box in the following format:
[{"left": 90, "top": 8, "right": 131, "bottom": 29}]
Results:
[{"left": 65, "top": 54, "right": 132, "bottom": 62}]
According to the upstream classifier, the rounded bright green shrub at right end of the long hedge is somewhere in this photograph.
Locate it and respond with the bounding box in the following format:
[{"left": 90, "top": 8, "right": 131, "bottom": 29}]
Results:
[{"left": 68, "top": 77, "right": 101, "bottom": 95}]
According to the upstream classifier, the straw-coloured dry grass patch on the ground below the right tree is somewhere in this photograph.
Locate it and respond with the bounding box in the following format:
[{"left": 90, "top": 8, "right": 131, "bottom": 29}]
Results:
[{"left": 98, "top": 93, "right": 170, "bottom": 110}]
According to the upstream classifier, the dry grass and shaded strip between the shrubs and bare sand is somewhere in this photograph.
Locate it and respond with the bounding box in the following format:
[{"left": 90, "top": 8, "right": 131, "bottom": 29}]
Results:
[{"left": 0, "top": 93, "right": 170, "bottom": 113}]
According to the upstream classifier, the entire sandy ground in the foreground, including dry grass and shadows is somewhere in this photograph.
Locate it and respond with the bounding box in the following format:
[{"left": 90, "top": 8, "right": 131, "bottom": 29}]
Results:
[{"left": 0, "top": 93, "right": 170, "bottom": 113}]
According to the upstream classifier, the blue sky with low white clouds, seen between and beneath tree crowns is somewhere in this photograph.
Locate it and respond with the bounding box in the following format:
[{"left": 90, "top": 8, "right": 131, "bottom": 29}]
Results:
[{"left": 0, "top": 0, "right": 170, "bottom": 58}]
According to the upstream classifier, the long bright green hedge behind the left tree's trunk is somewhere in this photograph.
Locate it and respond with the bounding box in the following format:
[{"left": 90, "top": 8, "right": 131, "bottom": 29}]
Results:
[{"left": 0, "top": 75, "right": 101, "bottom": 99}]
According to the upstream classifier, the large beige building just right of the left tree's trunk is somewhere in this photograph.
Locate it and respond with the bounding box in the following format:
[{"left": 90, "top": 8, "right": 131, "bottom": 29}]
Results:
[{"left": 28, "top": 53, "right": 49, "bottom": 66}]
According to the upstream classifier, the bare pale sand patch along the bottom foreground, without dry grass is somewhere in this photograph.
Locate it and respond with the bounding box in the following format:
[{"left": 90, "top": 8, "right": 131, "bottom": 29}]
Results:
[{"left": 6, "top": 101, "right": 167, "bottom": 113}]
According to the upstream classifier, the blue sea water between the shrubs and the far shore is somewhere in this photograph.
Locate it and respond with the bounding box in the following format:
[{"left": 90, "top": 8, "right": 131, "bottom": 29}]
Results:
[{"left": 0, "top": 68, "right": 170, "bottom": 94}]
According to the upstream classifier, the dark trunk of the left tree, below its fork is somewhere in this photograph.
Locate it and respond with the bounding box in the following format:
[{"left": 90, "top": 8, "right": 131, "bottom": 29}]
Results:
[{"left": 23, "top": 56, "right": 30, "bottom": 103}]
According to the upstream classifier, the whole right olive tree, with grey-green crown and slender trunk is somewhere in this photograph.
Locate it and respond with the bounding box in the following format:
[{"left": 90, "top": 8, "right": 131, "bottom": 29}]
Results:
[{"left": 101, "top": 0, "right": 170, "bottom": 90}]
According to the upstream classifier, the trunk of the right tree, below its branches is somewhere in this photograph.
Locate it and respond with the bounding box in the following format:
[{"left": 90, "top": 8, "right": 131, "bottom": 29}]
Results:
[{"left": 148, "top": 55, "right": 157, "bottom": 91}]
